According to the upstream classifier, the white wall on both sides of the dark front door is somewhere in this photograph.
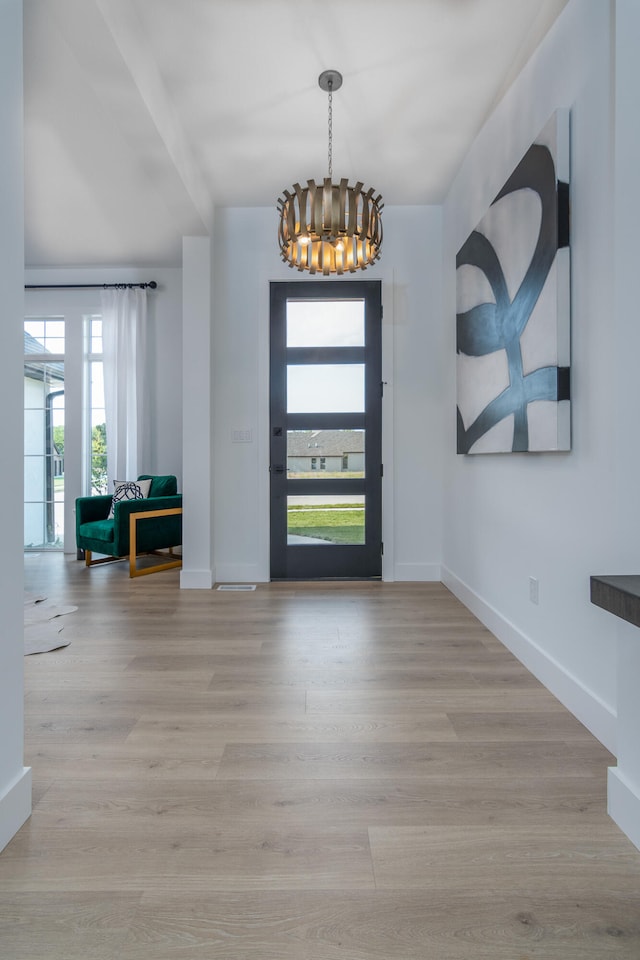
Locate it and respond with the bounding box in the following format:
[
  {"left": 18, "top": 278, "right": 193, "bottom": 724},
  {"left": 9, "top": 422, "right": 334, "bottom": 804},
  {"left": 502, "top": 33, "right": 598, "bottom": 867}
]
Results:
[{"left": 213, "top": 205, "right": 442, "bottom": 581}]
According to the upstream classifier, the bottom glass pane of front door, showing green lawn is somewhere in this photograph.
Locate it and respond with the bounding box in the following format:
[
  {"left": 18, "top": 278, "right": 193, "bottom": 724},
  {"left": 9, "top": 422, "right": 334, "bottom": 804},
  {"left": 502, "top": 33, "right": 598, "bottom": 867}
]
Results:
[{"left": 287, "top": 494, "right": 365, "bottom": 546}]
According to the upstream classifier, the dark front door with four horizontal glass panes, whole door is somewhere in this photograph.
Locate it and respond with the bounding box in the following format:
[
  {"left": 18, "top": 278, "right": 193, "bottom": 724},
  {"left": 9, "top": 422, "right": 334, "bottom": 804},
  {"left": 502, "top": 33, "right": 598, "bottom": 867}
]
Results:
[{"left": 270, "top": 280, "right": 382, "bottom": 580}]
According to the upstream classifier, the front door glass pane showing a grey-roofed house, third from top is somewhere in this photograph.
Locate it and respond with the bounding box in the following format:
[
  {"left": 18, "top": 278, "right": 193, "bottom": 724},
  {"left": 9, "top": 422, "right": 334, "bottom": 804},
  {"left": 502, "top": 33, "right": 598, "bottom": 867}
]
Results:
[{"left": 287, "top": 430, "right": 364, "bottom": 480}]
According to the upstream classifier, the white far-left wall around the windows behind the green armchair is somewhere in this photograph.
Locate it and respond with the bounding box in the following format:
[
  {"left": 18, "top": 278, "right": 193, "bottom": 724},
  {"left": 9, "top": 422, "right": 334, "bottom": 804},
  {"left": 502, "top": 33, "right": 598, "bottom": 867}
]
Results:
[{"left": 24, "top": 267, "right": 182, "bottom": 524}]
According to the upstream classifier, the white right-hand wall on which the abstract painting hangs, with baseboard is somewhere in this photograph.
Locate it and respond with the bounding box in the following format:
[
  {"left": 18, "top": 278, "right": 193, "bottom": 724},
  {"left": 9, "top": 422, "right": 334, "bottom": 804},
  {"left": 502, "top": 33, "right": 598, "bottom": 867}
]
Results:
[{"left": 443, "top": 0, "right": 616, "bottom": 748}]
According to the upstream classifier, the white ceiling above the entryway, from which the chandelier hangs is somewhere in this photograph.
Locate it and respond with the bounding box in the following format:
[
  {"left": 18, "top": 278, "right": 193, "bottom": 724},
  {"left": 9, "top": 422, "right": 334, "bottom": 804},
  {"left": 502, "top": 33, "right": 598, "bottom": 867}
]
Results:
[{"left": 24, "top": 0, "right": 567, "bottom": 266}]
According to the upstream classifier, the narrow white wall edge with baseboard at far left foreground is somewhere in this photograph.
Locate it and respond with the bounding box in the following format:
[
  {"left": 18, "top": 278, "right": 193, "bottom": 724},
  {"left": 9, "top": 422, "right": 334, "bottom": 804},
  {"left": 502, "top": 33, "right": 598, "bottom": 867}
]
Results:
[{"left": 0, "top": 0, "right": 31, "bottom": 850}]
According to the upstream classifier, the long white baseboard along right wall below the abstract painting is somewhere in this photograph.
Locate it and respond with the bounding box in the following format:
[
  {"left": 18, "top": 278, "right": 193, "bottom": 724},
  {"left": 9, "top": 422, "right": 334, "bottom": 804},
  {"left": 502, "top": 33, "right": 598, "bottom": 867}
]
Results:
[{"left": 442, "top": 566, "right": 616, "bottom": 754}]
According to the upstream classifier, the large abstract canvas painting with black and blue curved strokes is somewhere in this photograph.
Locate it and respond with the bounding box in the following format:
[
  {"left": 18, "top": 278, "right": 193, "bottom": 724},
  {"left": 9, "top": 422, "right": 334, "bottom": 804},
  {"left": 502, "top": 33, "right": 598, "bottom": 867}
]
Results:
[{"left": 456, "top": 110, "right": 571, "bottom": 453}]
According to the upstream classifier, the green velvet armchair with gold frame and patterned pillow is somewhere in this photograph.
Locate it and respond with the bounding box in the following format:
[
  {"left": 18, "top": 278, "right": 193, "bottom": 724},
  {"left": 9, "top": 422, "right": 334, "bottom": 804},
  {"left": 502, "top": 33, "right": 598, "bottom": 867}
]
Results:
[{"left": 76, "top": 474, "right": 182, "bottom": 577}]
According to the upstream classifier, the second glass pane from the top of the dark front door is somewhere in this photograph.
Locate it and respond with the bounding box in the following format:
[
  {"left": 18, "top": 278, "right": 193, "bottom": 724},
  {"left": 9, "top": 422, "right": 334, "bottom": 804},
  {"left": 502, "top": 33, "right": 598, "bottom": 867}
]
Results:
[{"left": 287, "top": 363, "right": 364, "bottom": 413}]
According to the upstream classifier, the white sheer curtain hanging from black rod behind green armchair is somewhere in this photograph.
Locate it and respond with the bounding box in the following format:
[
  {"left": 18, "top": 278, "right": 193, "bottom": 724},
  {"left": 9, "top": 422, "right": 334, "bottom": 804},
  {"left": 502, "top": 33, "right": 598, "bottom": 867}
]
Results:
[{"left": 102, "top": 287, "right": 149, "bottom": 491}]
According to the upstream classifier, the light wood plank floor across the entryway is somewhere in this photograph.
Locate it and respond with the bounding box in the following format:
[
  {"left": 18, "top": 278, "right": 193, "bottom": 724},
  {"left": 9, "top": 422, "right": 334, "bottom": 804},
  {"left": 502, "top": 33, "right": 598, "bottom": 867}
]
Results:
[{"left": 0, "top": 555, "right": 640, "bottom": 960}]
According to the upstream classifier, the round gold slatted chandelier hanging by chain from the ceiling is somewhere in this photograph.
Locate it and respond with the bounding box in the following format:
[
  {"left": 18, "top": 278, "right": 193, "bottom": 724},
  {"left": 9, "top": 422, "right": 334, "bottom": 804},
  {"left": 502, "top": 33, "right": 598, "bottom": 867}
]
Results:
[{"left": 278, "top": 70, "right": 383, "bottom": 276}]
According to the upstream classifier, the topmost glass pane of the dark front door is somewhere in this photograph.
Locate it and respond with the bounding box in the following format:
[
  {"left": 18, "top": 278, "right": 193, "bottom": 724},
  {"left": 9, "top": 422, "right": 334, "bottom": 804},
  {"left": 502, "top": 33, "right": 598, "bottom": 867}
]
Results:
[{"left": 287, "top": 300, "right": 364, "bottom": 347}]
